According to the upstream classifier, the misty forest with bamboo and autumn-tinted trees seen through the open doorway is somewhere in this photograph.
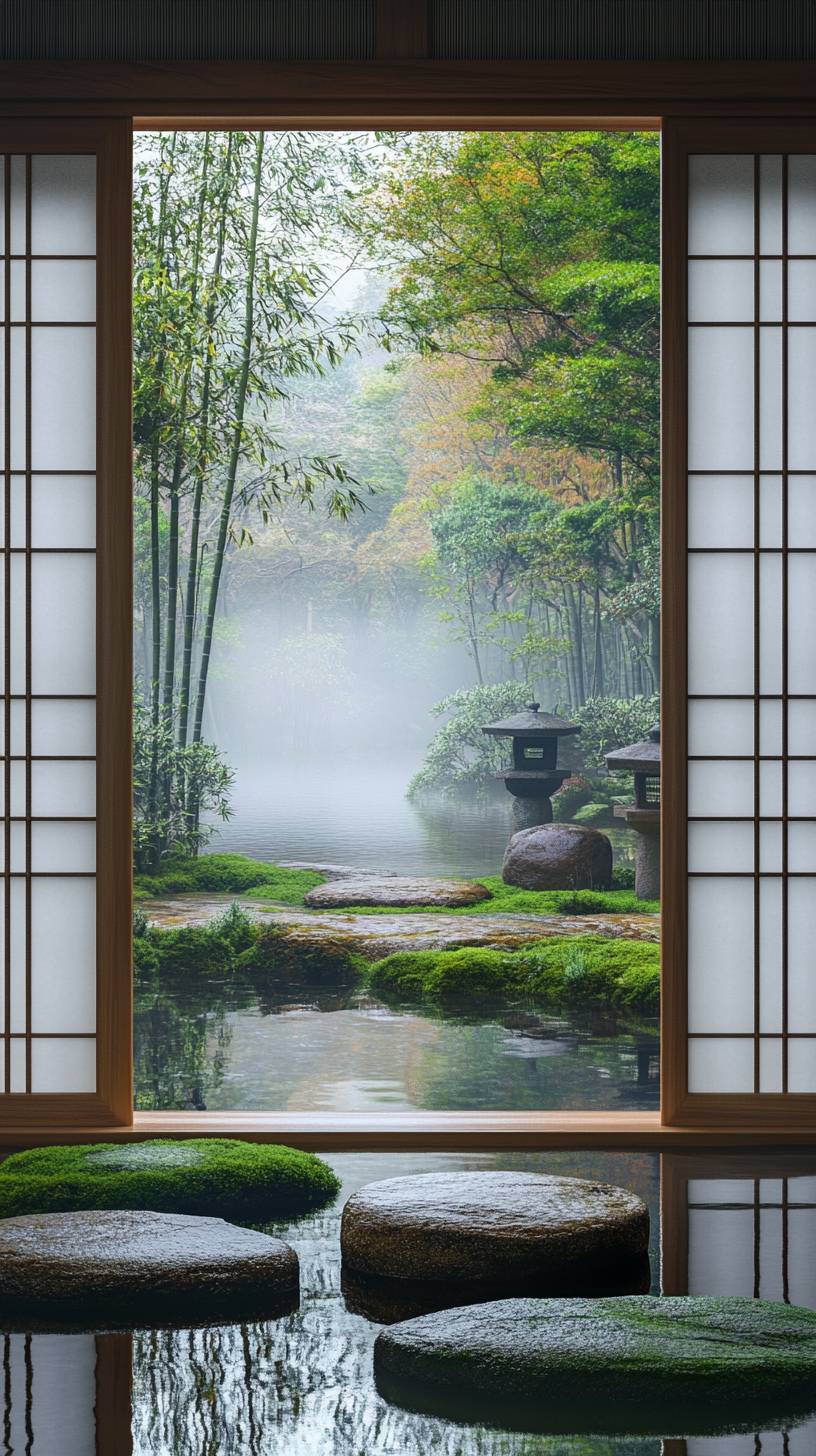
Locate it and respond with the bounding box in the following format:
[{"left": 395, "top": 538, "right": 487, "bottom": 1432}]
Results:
[{"left": 134, "top": 132, "right": 660, "bottom": 869}]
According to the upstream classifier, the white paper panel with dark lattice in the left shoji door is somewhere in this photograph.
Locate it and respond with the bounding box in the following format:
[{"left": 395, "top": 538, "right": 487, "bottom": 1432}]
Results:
[{"left": 0, "top": 154, "right": 96, "bottom": 1093}]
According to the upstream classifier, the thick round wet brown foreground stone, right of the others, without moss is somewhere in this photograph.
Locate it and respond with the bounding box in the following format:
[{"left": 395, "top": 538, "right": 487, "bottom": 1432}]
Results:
[{"left": 341, "top": 1172, "right": 648, "bottom": 1287}]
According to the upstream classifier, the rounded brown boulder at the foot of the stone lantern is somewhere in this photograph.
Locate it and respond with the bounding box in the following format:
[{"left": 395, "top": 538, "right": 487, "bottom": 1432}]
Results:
[{"left": 501, "top": 824, "right": 612, "bottom": 890}]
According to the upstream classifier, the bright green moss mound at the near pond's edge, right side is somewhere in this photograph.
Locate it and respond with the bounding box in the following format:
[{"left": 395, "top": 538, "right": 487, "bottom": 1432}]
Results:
[{"left": 367, "top": 935, "right": 660, "bottom": 1012}]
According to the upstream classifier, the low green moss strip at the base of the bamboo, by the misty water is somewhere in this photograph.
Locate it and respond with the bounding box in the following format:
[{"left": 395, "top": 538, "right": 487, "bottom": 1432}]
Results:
[{"left": 134, "top": 855, "right": 325, "bottom": 906}]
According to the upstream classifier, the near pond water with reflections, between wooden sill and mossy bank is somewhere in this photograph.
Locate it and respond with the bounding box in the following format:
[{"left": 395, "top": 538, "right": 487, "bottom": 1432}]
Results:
[{"left": 136, "top": 965, "right": 660, "bottom": 1111}]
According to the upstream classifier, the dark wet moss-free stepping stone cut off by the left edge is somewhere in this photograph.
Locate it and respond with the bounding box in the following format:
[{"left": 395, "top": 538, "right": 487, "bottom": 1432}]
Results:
[{"left": 0, "top": 1208, "right": 299, "bottom": 1325}]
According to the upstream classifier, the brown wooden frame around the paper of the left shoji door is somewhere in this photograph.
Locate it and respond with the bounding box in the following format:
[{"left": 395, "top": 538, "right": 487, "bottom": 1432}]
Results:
[{"left": 0, "top": 115, "right": 133, "bottom": 1142}]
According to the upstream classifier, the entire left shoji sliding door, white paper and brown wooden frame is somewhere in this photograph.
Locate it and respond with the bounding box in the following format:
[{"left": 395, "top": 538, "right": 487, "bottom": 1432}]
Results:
[{"left": 0, "top": 122, "right": 131, "bottom": 1127}]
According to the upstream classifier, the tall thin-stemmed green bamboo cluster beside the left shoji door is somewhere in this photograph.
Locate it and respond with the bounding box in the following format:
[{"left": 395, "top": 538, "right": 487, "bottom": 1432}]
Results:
[{"left": 134, "top": 131, "right": 373, "bottom": 828}]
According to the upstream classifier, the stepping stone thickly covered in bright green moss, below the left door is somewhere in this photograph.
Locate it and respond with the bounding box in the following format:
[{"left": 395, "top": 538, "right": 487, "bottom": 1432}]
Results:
[{"left": 0, "top": 1137, "right": 340, "bottom": 1223}]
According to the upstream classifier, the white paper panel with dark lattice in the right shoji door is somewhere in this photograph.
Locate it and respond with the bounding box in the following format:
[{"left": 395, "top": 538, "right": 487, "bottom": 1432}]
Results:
[{"left": 688, "top": 154, "right": 816, "bottom": 1095}]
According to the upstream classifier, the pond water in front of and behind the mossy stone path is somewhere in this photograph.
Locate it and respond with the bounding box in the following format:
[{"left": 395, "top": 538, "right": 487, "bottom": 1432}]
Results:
[{"left": 136, "top": 761, "right": 659, "bottom": 1112}]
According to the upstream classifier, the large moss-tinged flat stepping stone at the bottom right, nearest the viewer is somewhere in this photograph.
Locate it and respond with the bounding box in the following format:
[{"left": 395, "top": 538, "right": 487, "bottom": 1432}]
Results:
[{"left": 374, "top": 1296, "right": 816, "bottom": 1436}]
